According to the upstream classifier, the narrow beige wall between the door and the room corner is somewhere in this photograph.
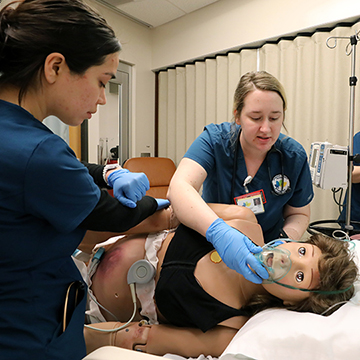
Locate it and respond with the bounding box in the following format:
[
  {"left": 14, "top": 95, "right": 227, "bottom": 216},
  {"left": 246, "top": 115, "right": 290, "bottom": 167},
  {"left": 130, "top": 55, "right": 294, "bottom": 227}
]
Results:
[{"left": 87, "top": 0, "right": 155, "bottom": 161}]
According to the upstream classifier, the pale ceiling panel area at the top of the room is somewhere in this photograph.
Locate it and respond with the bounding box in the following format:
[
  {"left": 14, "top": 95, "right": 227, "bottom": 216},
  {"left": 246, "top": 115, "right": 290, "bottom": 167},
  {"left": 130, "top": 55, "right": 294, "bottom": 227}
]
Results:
[{"left": 96, "top": 0, "right": 219, "bottom": 27}]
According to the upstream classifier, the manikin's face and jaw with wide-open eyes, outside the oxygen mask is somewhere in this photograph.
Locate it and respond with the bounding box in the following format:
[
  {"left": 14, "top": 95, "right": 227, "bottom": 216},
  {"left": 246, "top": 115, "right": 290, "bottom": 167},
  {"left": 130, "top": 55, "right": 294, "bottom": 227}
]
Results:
[{"left": 263, "top": 242, "right": 321, "bottom": 304}]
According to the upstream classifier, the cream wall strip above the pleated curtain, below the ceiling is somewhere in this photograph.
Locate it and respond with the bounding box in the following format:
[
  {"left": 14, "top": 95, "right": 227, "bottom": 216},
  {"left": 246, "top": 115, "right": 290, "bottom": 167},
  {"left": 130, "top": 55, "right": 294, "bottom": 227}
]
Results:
[{"left": 152, "top": 0, "right": 360, "bottom": 69}]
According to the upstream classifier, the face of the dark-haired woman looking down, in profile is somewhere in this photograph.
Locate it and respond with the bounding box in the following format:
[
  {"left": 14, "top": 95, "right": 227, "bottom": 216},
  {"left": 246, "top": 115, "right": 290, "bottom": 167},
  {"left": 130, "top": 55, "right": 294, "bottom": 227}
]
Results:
[{"left": 46, "top": 53, "right": 119, "bottom": 126}]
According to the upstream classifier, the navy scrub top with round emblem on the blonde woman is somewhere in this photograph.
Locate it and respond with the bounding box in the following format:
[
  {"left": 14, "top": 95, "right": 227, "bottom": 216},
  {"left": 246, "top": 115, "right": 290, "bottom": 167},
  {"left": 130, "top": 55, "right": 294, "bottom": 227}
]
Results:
[{"left": 184, "top": 122, "right": 314, "bottom": 242}]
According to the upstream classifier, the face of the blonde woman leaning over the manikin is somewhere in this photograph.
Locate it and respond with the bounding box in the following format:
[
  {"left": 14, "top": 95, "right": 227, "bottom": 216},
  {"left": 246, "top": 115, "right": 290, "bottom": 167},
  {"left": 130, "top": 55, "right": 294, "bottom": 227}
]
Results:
[{"left": 235, "top": 89, "right": 284, "bottom": 154}]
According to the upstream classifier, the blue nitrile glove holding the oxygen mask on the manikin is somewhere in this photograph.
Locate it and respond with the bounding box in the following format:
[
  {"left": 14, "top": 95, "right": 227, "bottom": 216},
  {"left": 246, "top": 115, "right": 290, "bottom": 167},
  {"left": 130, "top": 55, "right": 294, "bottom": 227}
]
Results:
[{"left": 206, "top": 218, "right": 269, "bottom": 284}]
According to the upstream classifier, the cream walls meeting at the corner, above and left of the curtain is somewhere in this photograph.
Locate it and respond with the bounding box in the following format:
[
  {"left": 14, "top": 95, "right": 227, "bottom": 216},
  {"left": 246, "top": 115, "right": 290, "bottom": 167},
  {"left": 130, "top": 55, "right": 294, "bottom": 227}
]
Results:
[{"left": 84, "top": 0, "right": 360, "bottom": 160}]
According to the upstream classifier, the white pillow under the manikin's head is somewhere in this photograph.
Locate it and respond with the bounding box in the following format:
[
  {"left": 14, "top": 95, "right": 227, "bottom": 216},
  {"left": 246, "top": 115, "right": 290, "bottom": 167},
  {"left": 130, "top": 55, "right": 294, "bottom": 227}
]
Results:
[{"left": 220, "top": 240, "right": 360, "bottom": 360}]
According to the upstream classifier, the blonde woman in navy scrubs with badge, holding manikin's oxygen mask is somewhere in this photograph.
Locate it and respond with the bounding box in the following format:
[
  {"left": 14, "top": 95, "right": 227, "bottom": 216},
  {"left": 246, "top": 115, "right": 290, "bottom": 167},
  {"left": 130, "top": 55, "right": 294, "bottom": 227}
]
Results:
[{"left": 168, "top": 71, "right": 313, "bottom": 283}]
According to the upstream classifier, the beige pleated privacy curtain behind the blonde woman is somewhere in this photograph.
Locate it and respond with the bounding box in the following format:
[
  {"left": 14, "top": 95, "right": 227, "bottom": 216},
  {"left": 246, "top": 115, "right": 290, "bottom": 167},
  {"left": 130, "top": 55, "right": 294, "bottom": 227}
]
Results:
[{"left": 157, "top": 22, "right": 360, "bottom": 221}]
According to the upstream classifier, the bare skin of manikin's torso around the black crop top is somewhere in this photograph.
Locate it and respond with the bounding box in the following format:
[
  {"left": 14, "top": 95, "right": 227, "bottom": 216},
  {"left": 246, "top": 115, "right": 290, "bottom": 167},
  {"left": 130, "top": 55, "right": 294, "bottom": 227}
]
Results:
[{"left": 91, "top": 220, "right": 264, "bottom": 329}]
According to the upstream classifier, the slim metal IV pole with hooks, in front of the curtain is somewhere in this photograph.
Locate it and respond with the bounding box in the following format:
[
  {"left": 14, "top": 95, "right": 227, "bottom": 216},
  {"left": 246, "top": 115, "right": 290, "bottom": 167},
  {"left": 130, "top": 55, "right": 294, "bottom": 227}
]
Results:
[{"left": 326, "top": 31, "right": 360, "bottom": 232}]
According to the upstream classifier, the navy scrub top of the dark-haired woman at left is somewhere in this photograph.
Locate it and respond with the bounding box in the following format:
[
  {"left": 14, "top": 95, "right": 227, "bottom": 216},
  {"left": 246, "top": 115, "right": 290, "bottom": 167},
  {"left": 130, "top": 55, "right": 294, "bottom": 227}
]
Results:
[{"left": 0, "top": 101, "right": 100, "bottom": 360}]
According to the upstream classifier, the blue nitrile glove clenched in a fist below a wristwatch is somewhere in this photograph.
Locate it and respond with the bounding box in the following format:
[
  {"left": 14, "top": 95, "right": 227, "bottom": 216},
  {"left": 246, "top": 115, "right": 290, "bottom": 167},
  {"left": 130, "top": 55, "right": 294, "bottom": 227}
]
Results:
[{"left": 107, "top": 169, "right": 150, "bottom": 209}]
